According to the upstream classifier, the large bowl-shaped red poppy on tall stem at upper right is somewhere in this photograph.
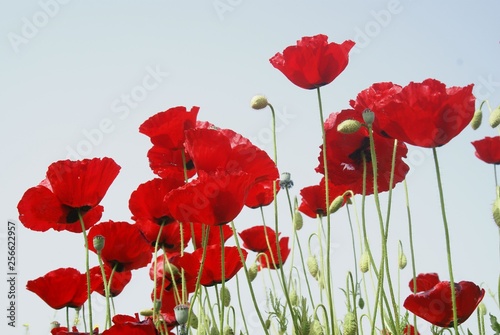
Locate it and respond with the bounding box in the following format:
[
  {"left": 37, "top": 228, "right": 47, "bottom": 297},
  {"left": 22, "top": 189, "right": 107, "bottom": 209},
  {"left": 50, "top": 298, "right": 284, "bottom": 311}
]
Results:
[{"left": 380, "top": 79, "right": 475, "bottom": 148}]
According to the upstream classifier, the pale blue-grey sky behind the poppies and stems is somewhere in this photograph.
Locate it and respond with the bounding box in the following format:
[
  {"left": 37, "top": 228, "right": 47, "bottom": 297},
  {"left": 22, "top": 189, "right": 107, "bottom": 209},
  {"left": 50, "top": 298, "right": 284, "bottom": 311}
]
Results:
[{"left": 0, "top": 0, "right": 500, "bottom": 335}]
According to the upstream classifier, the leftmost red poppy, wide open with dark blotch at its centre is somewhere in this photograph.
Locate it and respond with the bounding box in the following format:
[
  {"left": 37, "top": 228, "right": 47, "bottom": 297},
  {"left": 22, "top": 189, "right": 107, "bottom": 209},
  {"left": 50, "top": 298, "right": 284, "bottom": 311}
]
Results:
[{"left": 17, "top": 158, "right": 120, "bottom": 233}]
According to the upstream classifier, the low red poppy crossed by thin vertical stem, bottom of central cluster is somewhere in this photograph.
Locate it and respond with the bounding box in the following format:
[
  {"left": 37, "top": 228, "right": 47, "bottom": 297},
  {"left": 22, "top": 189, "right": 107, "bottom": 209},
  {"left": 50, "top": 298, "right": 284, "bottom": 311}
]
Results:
[{"left": 193, "top": 244, "right": 247, "bottom": 286}]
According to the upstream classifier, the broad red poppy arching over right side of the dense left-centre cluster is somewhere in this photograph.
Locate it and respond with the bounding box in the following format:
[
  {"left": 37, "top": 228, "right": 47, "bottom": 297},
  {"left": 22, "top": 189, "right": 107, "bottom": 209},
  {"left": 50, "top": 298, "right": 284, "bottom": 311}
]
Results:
[{"left": 186, "top": 128, "right": 279, "bottom": 208}]
